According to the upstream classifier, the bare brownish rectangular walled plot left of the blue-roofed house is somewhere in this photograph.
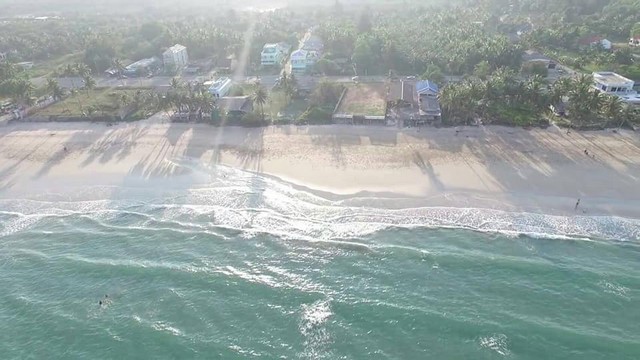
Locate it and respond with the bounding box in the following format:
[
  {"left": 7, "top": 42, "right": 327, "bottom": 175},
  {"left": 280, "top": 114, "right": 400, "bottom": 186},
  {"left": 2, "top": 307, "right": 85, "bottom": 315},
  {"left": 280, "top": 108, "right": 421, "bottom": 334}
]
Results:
[{"left": 336, "top": 83, "right": 387, "bottom": 116}]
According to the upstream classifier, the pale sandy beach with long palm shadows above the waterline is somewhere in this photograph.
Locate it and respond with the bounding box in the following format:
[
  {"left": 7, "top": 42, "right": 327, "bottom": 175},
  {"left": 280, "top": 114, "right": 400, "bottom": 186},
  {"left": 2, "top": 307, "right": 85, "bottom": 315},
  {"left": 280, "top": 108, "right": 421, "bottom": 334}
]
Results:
[{"left": 0, "top": 121, "right": 640, "bottom": 218}]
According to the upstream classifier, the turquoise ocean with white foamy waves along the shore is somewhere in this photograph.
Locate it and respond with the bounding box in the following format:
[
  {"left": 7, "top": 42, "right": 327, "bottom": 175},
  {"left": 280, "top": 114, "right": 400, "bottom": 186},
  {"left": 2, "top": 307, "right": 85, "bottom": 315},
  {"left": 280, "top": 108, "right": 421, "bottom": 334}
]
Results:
[{"left": 0, "top": 167, "right": 640, "bottom": 360}]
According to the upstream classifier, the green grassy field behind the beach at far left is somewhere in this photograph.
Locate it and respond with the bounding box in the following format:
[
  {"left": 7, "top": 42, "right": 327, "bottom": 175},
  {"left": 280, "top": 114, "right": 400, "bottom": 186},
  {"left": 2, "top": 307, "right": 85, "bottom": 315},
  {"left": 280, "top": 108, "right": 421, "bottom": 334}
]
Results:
[{"left": 37, "top": 88, "right": 154, "bottom": 117}]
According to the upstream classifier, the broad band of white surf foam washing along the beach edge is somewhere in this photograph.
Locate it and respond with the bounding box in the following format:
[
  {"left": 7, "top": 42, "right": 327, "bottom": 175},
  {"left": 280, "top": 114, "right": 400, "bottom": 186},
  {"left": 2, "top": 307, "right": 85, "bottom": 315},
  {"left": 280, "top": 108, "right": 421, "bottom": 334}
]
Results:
[{"left": 0, "top": 166, "right": 640, "bottom": 242}]
